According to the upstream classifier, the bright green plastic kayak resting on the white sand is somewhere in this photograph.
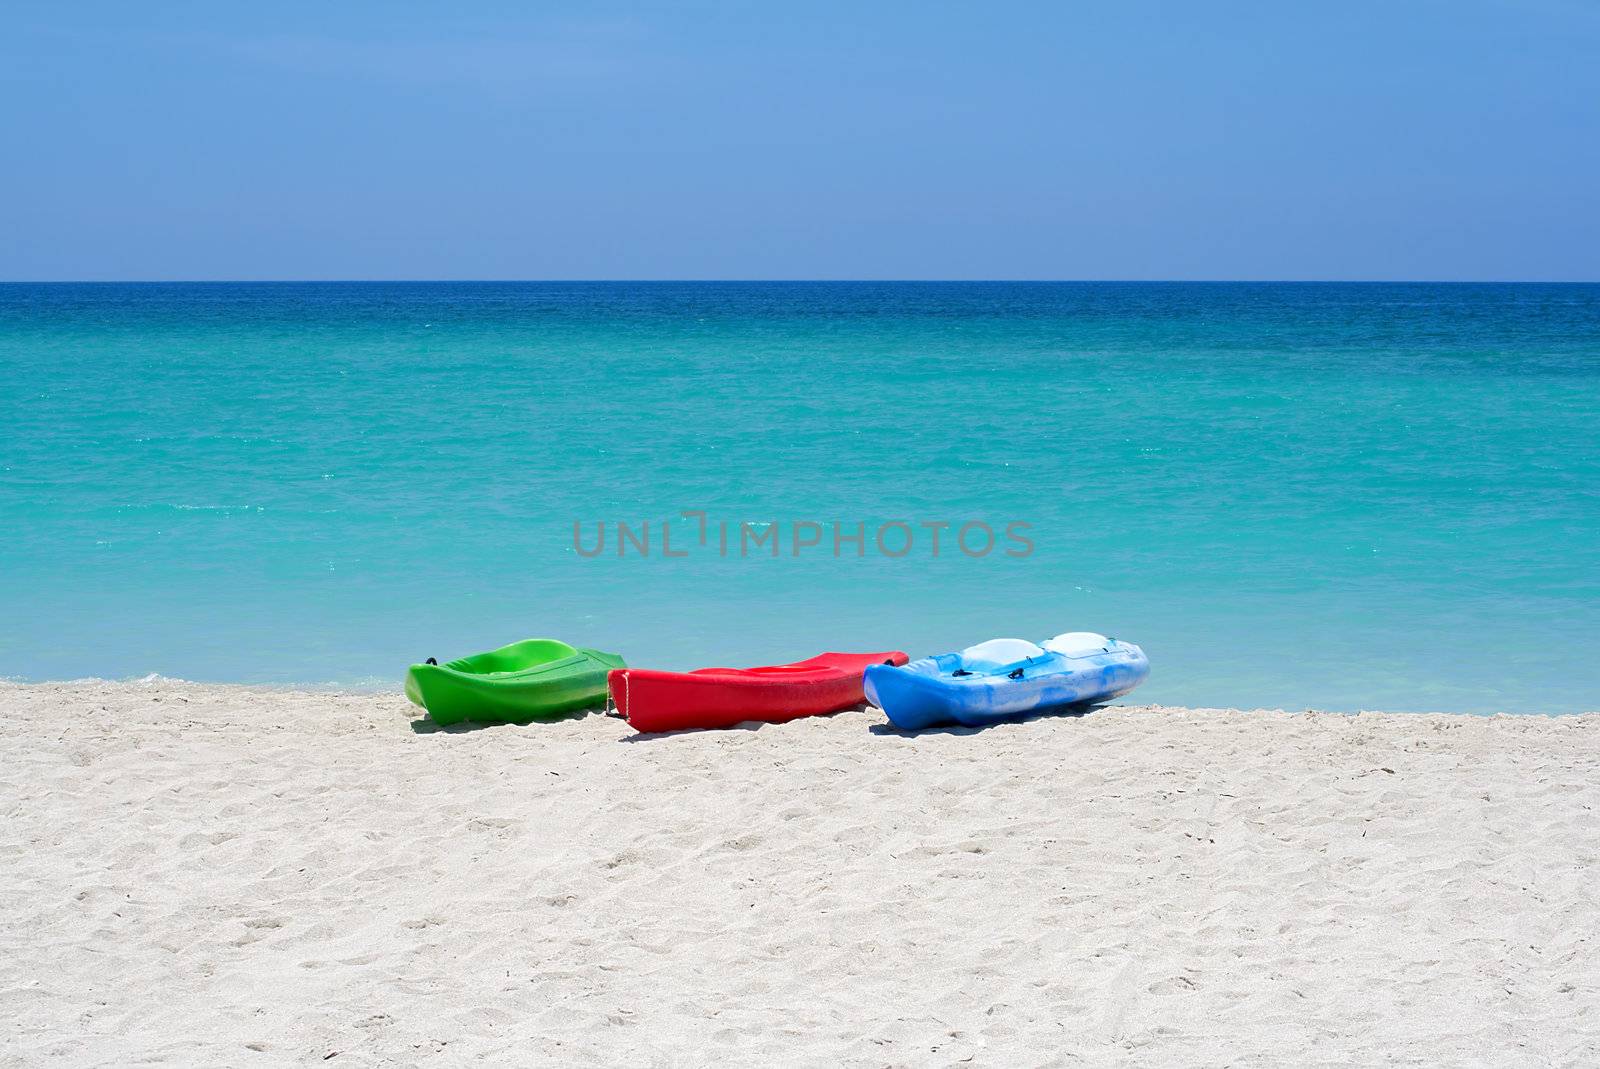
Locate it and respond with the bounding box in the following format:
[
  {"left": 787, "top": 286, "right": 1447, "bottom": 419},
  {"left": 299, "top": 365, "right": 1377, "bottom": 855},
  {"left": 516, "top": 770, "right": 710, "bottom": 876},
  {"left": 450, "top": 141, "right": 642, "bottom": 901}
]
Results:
[{"left": 405, "top": 639, "right": 626, "bottom": 723}]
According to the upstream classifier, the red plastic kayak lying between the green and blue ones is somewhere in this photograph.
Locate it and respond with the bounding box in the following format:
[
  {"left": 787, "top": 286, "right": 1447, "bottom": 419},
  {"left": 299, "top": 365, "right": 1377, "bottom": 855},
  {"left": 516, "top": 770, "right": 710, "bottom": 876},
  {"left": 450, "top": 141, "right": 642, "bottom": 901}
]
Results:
[{"left": 606, "top": 650, "right": 906, "bottom": 731}]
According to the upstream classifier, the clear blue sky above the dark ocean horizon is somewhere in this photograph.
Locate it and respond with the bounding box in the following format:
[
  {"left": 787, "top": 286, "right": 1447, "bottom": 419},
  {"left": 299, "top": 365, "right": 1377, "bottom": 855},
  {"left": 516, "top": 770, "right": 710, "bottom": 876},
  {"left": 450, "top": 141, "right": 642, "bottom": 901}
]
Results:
[{"left": 0, "top": 0, "right": 1600, "bottom": 280}]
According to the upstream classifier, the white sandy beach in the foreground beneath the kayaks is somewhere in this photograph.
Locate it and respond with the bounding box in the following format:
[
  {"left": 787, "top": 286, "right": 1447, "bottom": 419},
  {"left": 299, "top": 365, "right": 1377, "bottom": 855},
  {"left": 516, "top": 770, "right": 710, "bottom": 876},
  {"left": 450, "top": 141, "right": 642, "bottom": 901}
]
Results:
[{"left": 0, "top": 682, "right": 1600, "bottom": 1066}]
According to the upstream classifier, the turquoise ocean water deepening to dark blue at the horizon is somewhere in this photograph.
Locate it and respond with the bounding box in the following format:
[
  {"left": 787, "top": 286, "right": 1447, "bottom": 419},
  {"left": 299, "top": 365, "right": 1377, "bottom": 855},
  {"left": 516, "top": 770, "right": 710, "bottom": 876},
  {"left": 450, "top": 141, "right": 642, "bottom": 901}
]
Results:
[{"left": 0, "top": 283, "right": 1600, "bottom": 712}]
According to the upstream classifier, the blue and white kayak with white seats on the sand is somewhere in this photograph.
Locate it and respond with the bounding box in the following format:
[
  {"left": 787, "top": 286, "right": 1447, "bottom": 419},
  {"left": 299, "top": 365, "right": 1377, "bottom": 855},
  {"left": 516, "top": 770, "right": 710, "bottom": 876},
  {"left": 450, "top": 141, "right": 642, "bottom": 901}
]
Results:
[{"left": 864, "top": 631, "right": 1150, "bottom": 731}]
